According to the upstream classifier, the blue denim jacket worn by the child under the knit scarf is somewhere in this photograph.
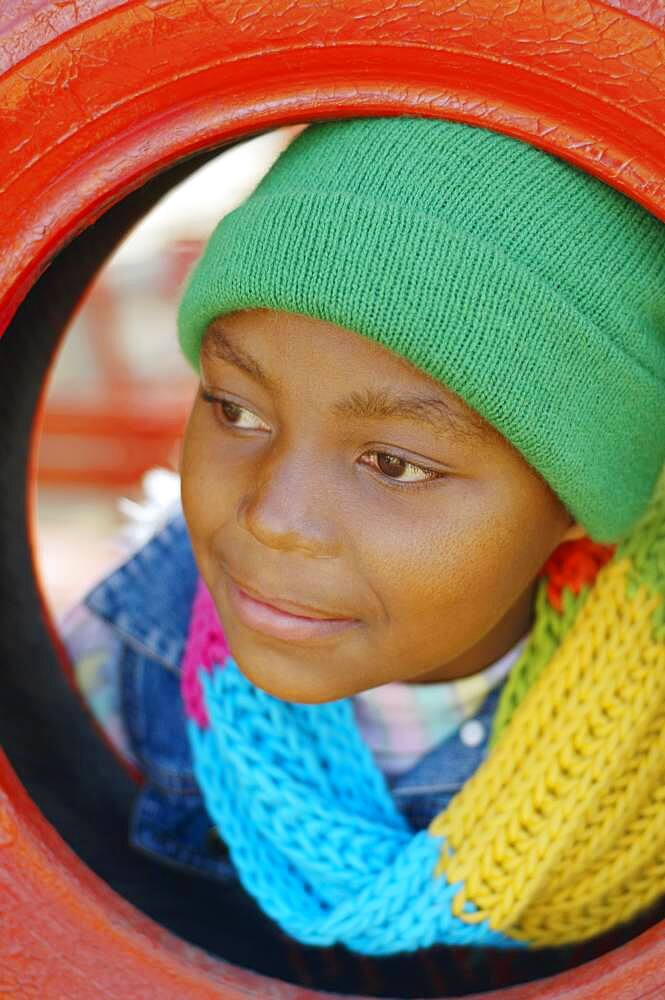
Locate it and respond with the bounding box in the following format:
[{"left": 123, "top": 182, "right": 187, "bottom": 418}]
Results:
[{"left": 79, "top": 513, "right": 505, "bottom": 881}]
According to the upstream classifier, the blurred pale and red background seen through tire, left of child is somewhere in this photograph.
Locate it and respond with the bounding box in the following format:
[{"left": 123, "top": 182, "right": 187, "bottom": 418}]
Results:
[{"left": 33, "top": 125, "right": 306, "bottom": 620}]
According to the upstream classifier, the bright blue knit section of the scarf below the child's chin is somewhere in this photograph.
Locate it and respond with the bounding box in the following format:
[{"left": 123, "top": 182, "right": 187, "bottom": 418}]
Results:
[{"left": 188, "top": 656, "right": 526, "bottom": 955}]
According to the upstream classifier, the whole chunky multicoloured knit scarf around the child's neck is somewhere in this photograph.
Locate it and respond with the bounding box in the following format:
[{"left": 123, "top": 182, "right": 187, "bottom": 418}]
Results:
[{"left": 183, "top": 475, "right": 665, "bottom": 955}]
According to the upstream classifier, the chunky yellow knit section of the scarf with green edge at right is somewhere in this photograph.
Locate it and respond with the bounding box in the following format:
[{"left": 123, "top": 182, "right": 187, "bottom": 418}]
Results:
[{"left": 429, "top": 470, "right": 665, "bottom": 947}]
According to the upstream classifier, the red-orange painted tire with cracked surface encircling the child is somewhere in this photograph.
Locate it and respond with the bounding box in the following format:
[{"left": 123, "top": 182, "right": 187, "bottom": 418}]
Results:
[{"left": 0, "top": 0, "right": 665, "bottom": 1000}]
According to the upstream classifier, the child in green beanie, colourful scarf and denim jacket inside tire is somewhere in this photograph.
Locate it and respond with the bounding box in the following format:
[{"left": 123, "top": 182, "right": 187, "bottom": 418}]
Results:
[{"left": 59, "top": 117, "right": 665, "bottom": 995}]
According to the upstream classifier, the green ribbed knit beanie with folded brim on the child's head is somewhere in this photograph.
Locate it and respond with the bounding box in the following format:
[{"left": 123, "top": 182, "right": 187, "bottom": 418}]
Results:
[{"left": 178, "top": 116, "right": 665, "bottom": 542}]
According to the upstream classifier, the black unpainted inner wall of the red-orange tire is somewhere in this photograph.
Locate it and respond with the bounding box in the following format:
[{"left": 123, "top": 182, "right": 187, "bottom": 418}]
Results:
[{"left": 0, "top": 135, "right": 665, "bottom": 998}]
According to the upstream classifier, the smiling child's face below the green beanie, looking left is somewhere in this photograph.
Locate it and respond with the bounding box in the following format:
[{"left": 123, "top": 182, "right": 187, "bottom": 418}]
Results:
[{"left": 181, "top": 309, "right": 583, "bottom": 703}]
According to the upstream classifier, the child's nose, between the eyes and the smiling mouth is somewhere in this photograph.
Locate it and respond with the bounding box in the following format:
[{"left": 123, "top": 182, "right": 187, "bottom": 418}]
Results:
[{"left": 237, "top": 452, "right": 339, "bottom": 559}]
